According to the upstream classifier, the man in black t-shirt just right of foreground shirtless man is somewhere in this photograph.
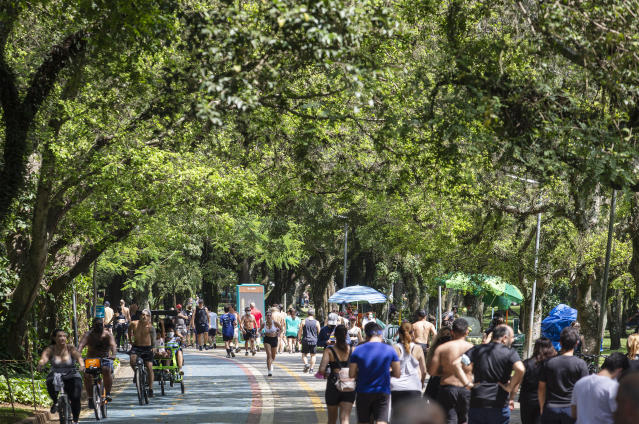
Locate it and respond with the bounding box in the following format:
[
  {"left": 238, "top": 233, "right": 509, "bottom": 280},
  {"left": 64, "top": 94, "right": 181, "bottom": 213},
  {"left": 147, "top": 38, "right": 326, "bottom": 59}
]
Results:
[{"left": 458, "top": 324, "right": 526, "bottom": 424}]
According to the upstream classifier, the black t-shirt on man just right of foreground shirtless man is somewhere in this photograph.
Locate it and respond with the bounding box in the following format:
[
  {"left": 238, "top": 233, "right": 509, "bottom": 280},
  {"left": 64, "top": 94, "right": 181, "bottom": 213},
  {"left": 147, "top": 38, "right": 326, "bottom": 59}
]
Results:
[{"left": 466, "top": 343, "right": 521, "bottom": 408}]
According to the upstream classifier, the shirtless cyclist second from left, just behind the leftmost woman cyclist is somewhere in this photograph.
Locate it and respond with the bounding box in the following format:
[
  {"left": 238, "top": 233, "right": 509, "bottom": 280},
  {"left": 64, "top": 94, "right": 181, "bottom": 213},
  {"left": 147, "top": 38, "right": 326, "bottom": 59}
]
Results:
[{"left": 78, "top": 318, "right": 117, "bottom": 408}]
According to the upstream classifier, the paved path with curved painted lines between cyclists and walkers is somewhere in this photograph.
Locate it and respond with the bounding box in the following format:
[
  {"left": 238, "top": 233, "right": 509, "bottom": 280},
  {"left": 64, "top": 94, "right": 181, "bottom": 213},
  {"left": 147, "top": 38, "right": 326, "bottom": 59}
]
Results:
[{"left": 80, "top": 348, "right": 520, "bottom": 424}]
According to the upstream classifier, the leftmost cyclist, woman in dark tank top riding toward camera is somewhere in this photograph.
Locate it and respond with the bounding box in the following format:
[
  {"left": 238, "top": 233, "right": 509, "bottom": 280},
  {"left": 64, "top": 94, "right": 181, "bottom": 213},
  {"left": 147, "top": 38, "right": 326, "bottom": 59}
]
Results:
[{"left": 37, "top": 329, "right": 84, "bottom": 423}]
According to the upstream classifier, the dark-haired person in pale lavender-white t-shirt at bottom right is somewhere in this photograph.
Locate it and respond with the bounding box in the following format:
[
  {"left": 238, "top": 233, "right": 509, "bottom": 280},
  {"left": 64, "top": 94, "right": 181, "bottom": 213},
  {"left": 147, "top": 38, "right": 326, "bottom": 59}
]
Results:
[{"left": 571, "top": 352, "right": 630, "bottom": 424}]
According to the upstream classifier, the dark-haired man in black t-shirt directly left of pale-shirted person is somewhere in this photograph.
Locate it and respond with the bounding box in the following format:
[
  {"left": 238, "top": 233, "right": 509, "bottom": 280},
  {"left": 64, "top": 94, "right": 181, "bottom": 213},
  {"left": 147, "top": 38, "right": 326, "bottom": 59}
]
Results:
[{"left": 538, "top": 327, "right": 588, "bottom": 424}]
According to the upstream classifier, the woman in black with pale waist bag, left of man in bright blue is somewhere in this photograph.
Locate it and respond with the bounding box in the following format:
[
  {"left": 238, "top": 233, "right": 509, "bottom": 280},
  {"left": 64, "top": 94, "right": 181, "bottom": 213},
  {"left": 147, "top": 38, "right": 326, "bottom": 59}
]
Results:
[{"left": 318, "top": 325, "right": 355, "bottom": 424}]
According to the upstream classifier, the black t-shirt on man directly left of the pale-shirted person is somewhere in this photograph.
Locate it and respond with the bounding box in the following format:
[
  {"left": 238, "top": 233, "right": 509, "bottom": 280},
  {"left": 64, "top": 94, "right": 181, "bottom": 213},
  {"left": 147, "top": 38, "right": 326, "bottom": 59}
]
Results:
[{"left": 539, "top": 355, "right": 588, "bottom": 408}]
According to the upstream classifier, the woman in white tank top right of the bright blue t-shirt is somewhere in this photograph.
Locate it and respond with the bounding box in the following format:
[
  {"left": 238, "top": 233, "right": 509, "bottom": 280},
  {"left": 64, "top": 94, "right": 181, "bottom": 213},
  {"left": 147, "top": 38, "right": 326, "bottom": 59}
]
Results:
[{"left": 391, "top": 322, "right": 426, "bottom": 423}]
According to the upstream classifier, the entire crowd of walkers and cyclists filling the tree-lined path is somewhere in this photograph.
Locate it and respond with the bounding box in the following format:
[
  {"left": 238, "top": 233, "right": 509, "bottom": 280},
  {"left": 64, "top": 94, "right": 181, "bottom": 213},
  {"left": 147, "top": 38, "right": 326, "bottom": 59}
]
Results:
[{"left": 38, "top": 299, "right": 639, "bottom": 424}]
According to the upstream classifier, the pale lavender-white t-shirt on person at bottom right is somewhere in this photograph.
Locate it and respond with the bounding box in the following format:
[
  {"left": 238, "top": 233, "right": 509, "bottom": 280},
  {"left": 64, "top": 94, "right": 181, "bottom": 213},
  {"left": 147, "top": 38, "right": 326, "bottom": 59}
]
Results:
[{"left": 572, "top": 374, "right": 619, "bottom": 424}]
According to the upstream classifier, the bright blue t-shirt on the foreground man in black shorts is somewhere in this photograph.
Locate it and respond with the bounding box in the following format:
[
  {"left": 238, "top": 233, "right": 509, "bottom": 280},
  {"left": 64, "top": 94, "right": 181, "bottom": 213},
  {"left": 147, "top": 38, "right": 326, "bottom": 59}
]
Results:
[{"left": 351, "top": 342, "right": 399, "bottom": 394}]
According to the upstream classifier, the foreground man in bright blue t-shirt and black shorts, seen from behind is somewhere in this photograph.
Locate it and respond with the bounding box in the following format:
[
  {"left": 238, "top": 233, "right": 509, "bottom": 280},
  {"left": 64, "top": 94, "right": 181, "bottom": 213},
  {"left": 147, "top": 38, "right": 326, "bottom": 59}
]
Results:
[{"left": 349, "top": 322, "right": 401, "bottom": 424}]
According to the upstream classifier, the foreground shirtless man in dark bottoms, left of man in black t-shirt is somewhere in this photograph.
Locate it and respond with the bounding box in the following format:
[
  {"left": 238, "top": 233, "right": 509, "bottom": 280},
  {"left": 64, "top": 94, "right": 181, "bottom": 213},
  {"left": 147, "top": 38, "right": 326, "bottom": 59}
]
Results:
[{"left": 428, "top": 318, "right": 473, "bottom": 424}]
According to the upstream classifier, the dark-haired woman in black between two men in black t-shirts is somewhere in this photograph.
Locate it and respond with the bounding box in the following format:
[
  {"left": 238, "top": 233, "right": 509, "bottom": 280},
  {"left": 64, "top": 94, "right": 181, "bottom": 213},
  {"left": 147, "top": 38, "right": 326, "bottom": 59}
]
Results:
[{"left": 519, "top": 337, "right": 557, "bottom": 424}]
